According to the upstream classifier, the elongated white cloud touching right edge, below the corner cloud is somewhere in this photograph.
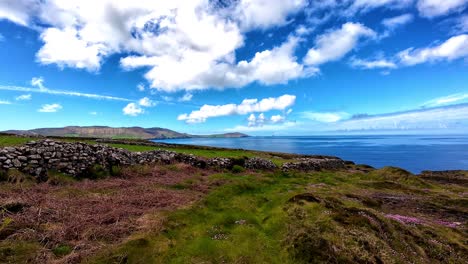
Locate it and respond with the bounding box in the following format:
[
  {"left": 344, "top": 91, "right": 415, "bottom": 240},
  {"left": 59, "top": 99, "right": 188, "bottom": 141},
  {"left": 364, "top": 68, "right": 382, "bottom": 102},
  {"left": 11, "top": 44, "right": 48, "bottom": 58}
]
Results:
[{"left": 397, "top": 34, "right": 468, "bottom": 65}]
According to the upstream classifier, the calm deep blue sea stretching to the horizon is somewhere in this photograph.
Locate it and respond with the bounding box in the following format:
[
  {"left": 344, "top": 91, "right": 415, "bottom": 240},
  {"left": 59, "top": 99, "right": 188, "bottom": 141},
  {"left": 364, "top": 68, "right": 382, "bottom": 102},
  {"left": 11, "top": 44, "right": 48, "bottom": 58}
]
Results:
[{"left": 151, "top": 135, "right": 468, "bottom": 173}]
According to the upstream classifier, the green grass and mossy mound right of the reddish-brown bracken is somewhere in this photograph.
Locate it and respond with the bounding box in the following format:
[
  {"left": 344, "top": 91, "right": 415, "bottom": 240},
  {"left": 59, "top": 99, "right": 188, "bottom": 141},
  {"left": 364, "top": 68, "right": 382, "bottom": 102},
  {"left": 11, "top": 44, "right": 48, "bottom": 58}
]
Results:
[{"left": 89, "top": 169, "right": 468, "bottom": 263}]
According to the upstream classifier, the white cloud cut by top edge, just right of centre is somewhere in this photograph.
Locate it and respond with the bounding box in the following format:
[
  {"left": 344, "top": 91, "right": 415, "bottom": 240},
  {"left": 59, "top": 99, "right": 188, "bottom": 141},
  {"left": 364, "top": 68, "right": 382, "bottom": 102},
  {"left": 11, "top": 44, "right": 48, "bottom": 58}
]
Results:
[{"left": 234, "top": 0, "right": 307, "bottom": 30}]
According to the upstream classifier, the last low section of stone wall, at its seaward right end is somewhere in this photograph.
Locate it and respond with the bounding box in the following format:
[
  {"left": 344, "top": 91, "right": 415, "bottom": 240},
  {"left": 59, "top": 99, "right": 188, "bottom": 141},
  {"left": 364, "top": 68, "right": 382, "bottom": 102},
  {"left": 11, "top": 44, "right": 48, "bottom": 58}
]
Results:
[{"left": 281, "top": 158, "right": 345, "bottom": 171}]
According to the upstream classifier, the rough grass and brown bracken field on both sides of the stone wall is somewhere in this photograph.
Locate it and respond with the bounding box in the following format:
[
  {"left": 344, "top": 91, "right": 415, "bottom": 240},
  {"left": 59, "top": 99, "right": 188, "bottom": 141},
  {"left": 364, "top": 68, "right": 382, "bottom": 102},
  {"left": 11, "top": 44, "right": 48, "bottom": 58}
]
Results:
[{"left": 0, "top": 137, "right": 468, "bottom": 264}]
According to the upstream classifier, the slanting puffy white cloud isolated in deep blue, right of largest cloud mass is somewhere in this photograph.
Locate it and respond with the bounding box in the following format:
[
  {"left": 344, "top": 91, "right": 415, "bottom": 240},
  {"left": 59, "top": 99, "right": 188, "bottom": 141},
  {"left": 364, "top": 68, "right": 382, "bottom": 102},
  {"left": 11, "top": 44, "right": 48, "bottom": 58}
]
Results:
[{"left": 304, "top": 22, "right": 376, "bottom": 65}]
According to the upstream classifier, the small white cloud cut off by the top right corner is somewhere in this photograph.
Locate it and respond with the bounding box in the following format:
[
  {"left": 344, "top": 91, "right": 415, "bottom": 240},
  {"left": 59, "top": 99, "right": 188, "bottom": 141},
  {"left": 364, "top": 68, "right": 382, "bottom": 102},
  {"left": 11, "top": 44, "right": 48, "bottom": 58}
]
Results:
[{"left": 417, "top": 0, "right": 468, "bottom": 18}]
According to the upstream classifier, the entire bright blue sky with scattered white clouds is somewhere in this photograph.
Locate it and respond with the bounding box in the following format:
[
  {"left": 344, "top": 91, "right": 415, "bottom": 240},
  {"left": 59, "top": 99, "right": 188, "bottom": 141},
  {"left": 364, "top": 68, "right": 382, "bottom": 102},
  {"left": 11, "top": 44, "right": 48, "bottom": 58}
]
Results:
[{"left": 0, "top": 0, "right": 468, "bottom": 135}]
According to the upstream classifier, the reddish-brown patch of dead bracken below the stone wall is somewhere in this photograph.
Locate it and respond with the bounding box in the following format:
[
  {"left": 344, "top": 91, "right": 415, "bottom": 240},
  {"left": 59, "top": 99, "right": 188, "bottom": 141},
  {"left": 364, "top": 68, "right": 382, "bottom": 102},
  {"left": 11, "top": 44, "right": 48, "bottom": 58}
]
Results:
[{"left": 0, "top": 164, "right": 218, "bottom": 263}]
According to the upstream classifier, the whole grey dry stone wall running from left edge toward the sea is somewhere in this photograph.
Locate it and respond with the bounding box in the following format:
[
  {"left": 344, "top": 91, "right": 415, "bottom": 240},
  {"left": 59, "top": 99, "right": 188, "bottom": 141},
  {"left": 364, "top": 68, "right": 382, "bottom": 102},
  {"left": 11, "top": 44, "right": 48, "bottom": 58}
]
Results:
[{"left": 0, "top": 139, "right": 344, "bottom": 179}]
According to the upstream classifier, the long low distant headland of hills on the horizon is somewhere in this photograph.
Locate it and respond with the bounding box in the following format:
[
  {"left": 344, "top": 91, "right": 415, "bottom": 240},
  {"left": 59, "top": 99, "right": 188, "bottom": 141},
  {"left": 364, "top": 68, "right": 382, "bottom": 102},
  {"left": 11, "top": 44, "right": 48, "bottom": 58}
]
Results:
[{"left": 4, "top": 126, "right": 247, "bottom": 139}]
